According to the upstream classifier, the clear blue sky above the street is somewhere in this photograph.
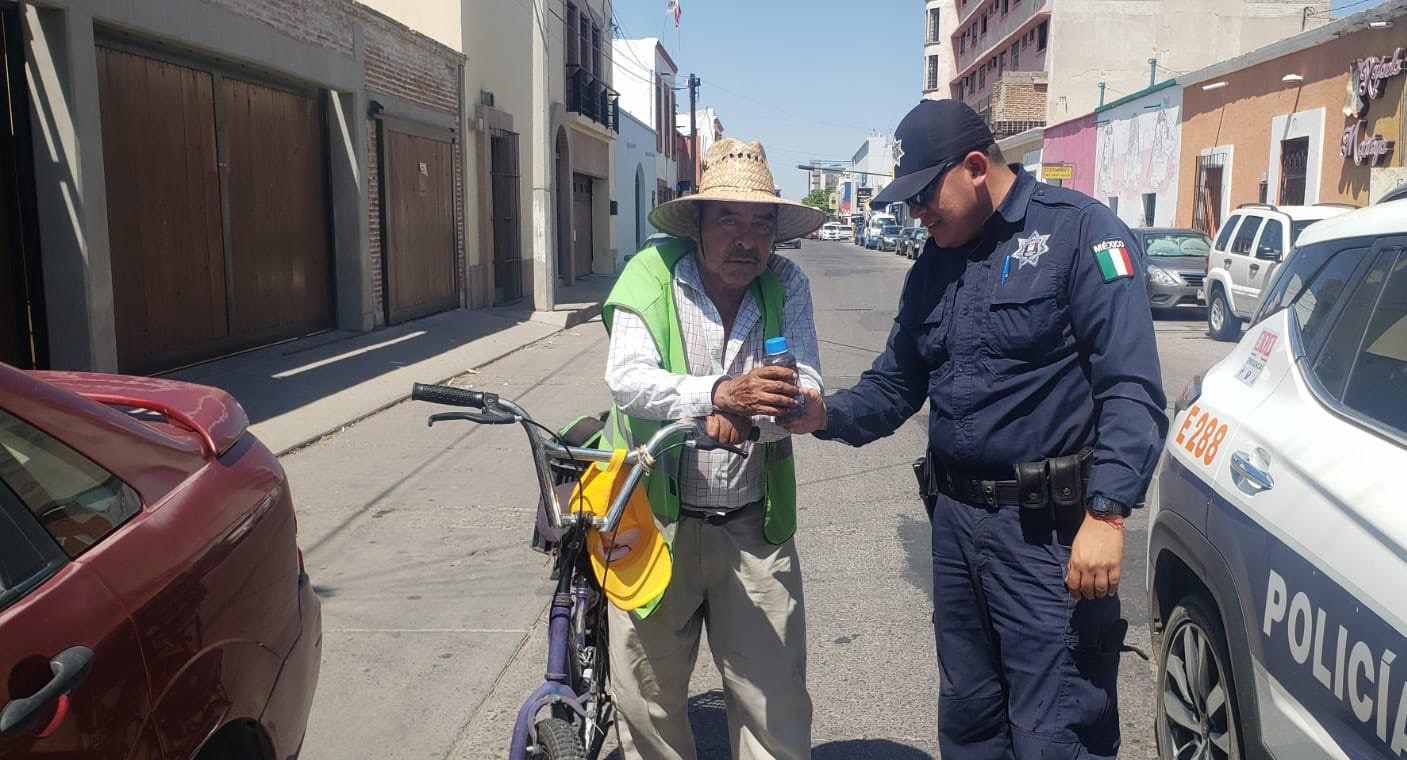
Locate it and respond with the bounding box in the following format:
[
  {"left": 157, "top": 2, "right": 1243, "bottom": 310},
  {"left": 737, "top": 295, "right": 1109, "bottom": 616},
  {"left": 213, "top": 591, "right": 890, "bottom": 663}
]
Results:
[{"left": 615, "top": 0, "right": 1383, "bottom": 198}]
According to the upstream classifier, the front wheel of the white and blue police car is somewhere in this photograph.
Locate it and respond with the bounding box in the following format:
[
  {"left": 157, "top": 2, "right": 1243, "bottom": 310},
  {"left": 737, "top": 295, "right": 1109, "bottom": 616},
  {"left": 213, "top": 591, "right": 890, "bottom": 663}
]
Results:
[{"left": 1157, "top": 595, "right": 1242, "bottom": 760}]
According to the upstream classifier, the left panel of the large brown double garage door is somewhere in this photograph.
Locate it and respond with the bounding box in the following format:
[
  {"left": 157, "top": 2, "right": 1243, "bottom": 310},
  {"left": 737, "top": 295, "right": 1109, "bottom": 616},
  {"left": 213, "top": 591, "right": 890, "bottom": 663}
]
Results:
[{"left": 97, "top": 48, "right": 229, "bottom": 372}]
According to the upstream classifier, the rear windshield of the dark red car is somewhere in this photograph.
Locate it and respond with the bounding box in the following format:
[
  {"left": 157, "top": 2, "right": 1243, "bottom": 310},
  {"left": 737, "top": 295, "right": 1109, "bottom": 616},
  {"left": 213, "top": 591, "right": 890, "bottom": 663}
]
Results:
[{"left": 0, "top": 411, "right": 142, "bottom": 557}]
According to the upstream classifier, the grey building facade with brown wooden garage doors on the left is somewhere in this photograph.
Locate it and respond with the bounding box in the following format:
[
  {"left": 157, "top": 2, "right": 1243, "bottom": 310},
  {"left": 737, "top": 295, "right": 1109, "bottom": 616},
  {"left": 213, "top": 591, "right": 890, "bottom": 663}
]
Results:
[{"left": 0, "top": 0, "right": 476, "bottom": 372}]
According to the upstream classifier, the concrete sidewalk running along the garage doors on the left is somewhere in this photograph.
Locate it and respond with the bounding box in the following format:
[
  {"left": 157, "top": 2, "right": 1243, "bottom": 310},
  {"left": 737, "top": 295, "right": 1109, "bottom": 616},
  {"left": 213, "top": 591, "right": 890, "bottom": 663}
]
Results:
[{"left": 167, "top": 274, "right": 615, "bottom": 456}]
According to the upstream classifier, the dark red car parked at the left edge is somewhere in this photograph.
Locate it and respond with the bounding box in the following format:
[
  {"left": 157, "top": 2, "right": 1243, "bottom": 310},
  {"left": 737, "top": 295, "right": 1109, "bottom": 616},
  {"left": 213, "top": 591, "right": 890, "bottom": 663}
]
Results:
[{"left": 0, "top": 365, "right": 322, "bottom": 760}]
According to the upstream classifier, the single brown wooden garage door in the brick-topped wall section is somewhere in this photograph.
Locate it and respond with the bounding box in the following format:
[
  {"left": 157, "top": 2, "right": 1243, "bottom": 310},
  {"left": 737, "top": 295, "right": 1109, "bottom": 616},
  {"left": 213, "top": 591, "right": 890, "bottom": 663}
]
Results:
[{"left": 383, "top": 127, "right": 459, "bottom": 324}]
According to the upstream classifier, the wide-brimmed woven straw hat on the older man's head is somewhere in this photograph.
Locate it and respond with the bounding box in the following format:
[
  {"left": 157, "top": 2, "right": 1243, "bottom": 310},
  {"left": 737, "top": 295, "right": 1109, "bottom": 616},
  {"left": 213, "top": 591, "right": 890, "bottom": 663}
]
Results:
[{"left": 650, "top": 138, "right": 826, "bottom": 241}]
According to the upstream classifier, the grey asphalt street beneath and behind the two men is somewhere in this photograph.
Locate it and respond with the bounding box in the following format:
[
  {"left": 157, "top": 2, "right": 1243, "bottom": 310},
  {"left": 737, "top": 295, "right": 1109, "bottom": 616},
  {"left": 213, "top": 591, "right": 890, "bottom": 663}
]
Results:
[{"left": 283, "top": 241, "right": 1231, "bottom": 760}]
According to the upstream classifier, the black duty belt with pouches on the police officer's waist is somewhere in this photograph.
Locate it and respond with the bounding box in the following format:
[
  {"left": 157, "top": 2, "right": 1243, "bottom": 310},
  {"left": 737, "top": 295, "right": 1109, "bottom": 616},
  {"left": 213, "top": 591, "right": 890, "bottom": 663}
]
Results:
[{"left": 930, "top": 449, "right": 1090, "bottom": 509}]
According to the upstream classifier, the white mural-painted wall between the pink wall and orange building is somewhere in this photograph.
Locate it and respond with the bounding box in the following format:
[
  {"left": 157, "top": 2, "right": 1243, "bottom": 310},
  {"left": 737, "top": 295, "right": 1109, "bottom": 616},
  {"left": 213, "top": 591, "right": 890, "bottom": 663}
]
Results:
[{"left": 1095, "top": 86, "right": 1182, "bottom": 227}]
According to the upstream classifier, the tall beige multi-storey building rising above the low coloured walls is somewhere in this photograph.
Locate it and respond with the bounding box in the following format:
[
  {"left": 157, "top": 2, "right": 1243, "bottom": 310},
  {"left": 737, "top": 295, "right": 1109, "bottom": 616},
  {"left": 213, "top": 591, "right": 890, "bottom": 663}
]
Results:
[{"left": 924, "top": 0, "right": 1330, "bottom": 138}]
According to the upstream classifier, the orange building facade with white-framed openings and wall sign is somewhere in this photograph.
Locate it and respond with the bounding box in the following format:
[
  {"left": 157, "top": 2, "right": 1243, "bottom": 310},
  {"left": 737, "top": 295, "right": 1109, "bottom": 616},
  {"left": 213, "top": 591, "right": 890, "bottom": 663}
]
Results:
[{"left": 1178, "top": 0, "right": 1407, "bottom": 232}]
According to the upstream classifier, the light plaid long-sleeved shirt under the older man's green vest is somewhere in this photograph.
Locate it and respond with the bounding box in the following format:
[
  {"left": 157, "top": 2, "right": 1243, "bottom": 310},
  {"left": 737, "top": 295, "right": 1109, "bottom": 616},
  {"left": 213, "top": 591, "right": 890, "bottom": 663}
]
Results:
[{"left": 606, "top": 255, "right": 823, "bottom": 511}]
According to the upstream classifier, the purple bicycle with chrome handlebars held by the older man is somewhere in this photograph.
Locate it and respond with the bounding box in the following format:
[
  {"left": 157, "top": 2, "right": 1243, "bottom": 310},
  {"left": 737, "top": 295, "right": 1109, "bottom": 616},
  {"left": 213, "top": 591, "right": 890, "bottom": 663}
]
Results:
[{"left": 411, "top": 383, "right": 756, "bottom": 760}]
